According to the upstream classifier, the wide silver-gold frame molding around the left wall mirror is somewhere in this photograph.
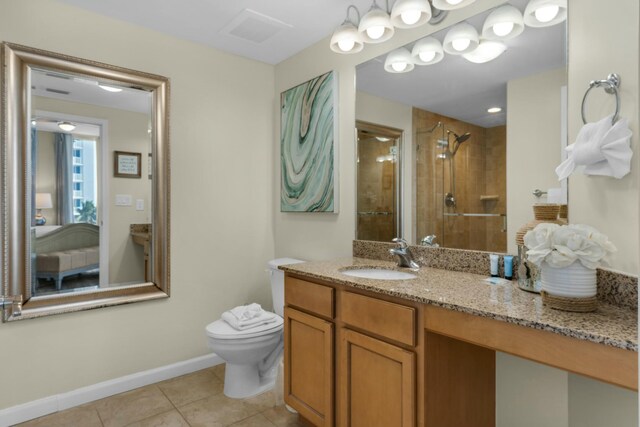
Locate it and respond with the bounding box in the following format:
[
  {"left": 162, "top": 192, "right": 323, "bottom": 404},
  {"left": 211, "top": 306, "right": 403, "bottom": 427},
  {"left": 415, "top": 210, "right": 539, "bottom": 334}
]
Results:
[{"left": 0, "top": 42, "right": 171, "bottom": 322}]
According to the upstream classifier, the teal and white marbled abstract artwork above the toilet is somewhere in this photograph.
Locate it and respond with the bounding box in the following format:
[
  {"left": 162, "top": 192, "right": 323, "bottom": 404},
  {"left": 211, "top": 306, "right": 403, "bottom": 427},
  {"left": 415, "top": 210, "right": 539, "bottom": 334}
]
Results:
[{"left": 280, "top": 71, "right": 338, "bottom": 212}]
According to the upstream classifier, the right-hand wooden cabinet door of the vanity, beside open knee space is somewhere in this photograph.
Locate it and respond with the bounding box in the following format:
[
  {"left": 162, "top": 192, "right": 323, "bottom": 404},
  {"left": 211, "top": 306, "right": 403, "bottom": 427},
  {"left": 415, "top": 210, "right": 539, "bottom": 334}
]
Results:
[{"left": 339, "top": 329, "right": 416, "bottom": 427}]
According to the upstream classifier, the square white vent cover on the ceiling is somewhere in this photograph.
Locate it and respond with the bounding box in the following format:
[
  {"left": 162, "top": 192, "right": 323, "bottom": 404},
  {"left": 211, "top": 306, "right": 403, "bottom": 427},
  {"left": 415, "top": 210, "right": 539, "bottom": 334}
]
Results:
[{"left": 220, "top": 9, "right": 293, "bottom": 44}]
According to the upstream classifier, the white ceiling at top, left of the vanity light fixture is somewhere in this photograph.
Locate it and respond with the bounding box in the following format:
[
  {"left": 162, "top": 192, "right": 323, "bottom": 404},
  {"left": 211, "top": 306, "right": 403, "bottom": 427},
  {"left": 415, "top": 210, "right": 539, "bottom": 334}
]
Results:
[{"left": 59, "top": 0, "right": 376, "bottom": 64}]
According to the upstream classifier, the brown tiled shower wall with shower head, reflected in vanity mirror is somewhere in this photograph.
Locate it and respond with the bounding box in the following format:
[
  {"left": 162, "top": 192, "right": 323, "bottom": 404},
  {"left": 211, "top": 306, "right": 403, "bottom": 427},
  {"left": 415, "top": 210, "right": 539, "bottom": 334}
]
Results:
[{"left": 413, "top": 108, "right": 507, "bottom": 251}]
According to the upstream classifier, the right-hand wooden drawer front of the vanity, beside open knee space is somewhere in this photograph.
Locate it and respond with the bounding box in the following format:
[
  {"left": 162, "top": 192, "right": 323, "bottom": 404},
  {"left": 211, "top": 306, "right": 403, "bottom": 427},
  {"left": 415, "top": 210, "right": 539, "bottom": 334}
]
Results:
[{"left": 340, "top": 292, "right": 416, "bottom": 346}]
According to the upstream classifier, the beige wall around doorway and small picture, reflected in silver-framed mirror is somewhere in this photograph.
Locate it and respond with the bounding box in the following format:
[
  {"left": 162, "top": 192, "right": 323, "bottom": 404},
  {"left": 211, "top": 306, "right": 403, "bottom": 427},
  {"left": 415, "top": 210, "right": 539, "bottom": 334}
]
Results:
[{"left": 33, "top": 97, "right": 151, "bottom": 283}]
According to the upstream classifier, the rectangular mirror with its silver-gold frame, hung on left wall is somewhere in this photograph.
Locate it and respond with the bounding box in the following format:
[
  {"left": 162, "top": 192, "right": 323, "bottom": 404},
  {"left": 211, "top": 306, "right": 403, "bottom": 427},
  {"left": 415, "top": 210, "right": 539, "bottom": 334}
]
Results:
[{"left": 2, "top": 43, "right": 169, "bottom": 321}]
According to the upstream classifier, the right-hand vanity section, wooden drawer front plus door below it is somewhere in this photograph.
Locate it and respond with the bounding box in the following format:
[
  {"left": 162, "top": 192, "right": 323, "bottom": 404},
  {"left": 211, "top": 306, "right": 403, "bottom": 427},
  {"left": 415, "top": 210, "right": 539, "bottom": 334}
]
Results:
[{"left": 337, "top": 291, "right": 417, "bottom": 427}]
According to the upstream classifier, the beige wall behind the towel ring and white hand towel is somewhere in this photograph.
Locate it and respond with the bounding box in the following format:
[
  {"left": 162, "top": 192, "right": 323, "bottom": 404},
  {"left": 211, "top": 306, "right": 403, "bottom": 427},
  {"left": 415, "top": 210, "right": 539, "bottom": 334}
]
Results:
[{"left": 569, "top": 0, "right": 640, "bottom": 274}]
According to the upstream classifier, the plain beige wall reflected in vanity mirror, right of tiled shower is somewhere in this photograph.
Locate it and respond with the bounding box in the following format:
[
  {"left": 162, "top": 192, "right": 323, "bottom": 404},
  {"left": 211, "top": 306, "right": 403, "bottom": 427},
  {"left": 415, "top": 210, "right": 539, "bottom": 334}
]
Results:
[{"left": 507, "top": 67, "right": 568, "bottom": 254}]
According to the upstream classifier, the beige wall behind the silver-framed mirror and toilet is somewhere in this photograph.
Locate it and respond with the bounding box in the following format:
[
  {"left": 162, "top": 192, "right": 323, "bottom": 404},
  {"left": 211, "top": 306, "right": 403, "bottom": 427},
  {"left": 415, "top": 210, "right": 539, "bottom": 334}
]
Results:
[{"left": 0, "top": 0, "right": 276, "bottom": 408}]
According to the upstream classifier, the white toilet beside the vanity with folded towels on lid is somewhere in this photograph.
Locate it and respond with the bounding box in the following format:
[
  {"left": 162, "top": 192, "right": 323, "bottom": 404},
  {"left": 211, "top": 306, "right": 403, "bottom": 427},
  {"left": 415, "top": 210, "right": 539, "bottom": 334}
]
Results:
[{"left": 206, "top": 258, "right": 304, "bottom": 398}]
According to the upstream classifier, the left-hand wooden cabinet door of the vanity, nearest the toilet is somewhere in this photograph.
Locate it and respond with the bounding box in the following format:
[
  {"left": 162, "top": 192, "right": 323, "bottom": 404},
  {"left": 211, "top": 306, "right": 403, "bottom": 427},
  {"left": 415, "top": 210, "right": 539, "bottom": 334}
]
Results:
[{"left": 284, "top": 307, "right": 334, "bottom": 427}]
